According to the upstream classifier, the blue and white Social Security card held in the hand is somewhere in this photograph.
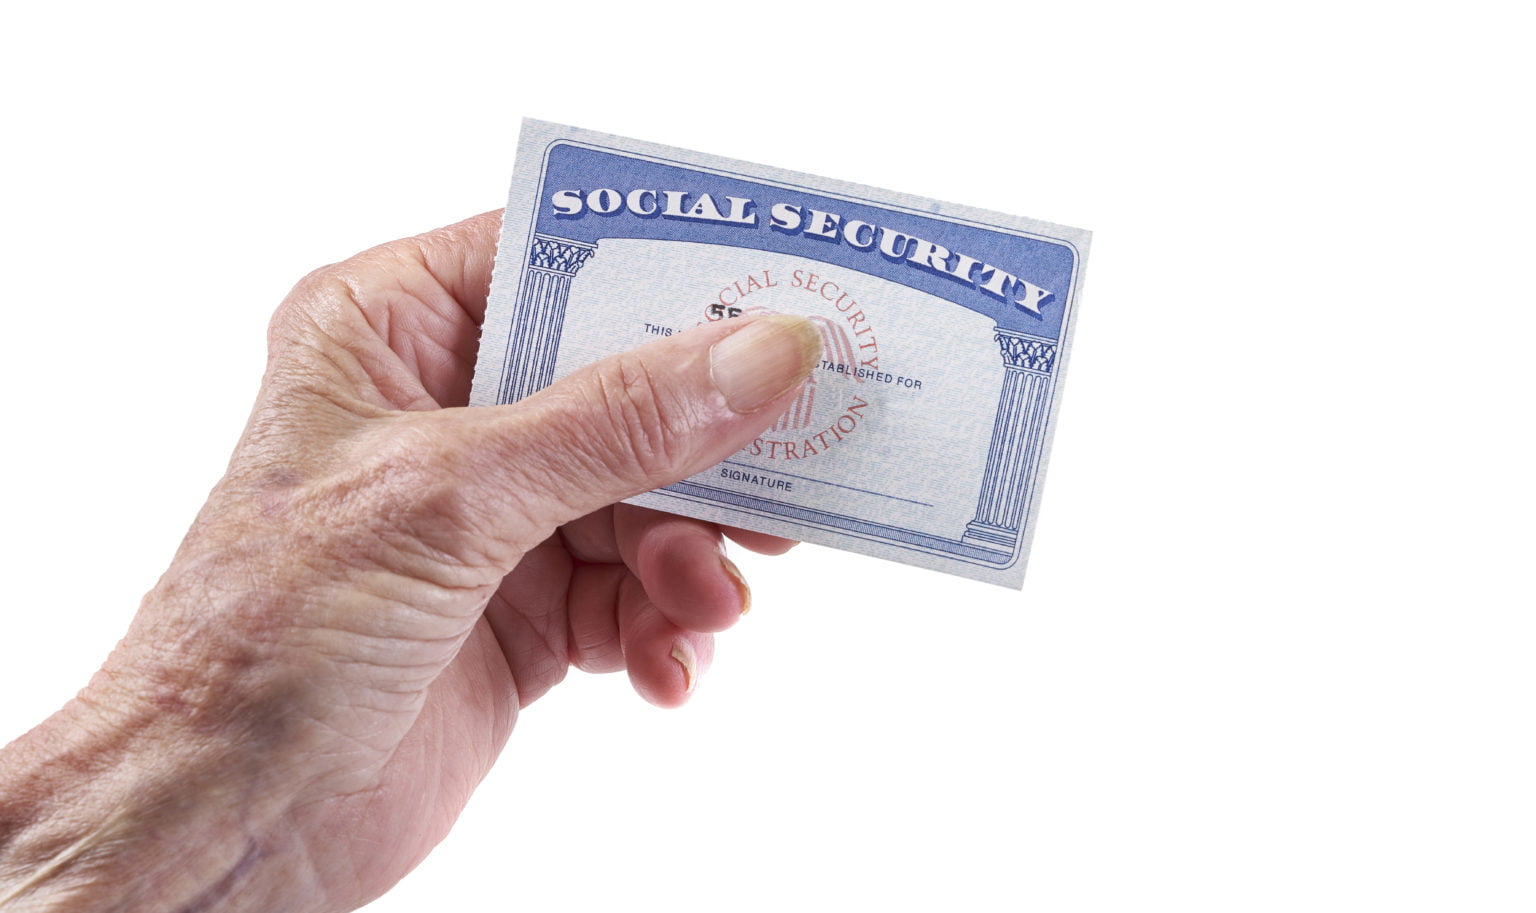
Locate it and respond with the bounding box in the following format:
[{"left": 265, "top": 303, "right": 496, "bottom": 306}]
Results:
[{"left": 472, "top": 120, "right": 1089, "bottom": 587}]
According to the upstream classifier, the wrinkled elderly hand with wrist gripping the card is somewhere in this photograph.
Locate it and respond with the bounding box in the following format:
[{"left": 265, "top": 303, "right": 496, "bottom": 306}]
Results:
[{"left": 0, "top": 212, "right": 819, "bottom": 910}]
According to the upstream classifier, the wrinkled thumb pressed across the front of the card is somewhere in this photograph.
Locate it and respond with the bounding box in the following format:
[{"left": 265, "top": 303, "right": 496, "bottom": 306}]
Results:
[{"left": 433, "top": 315, "right": 822, "bottom": 553}]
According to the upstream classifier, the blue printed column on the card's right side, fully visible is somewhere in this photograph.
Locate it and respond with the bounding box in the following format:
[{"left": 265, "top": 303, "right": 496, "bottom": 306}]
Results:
[{"left": 963, "top": 327, "right": 1057, "bottom": 555}]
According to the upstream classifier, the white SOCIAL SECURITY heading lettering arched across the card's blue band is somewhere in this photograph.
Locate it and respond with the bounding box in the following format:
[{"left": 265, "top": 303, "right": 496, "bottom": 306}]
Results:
[{"left": 550, "top": 188, "right": 1051, "bottom": 315}]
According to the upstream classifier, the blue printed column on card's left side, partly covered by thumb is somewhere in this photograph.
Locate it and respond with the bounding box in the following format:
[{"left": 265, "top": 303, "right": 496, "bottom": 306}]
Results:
[{"left": 498, "top": 235, "right": 598, "bottom": 403}]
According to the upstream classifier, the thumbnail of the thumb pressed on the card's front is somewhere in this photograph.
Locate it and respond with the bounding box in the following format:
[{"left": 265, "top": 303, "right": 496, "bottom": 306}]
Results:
[{"left": 710, "top": 314, "right": 822, "bottom": 413}]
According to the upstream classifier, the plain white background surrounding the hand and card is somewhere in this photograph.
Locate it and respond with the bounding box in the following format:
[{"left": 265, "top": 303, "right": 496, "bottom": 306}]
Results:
[{"left": 0, "top": 2, "right": 1536, "bottom": 913}]
